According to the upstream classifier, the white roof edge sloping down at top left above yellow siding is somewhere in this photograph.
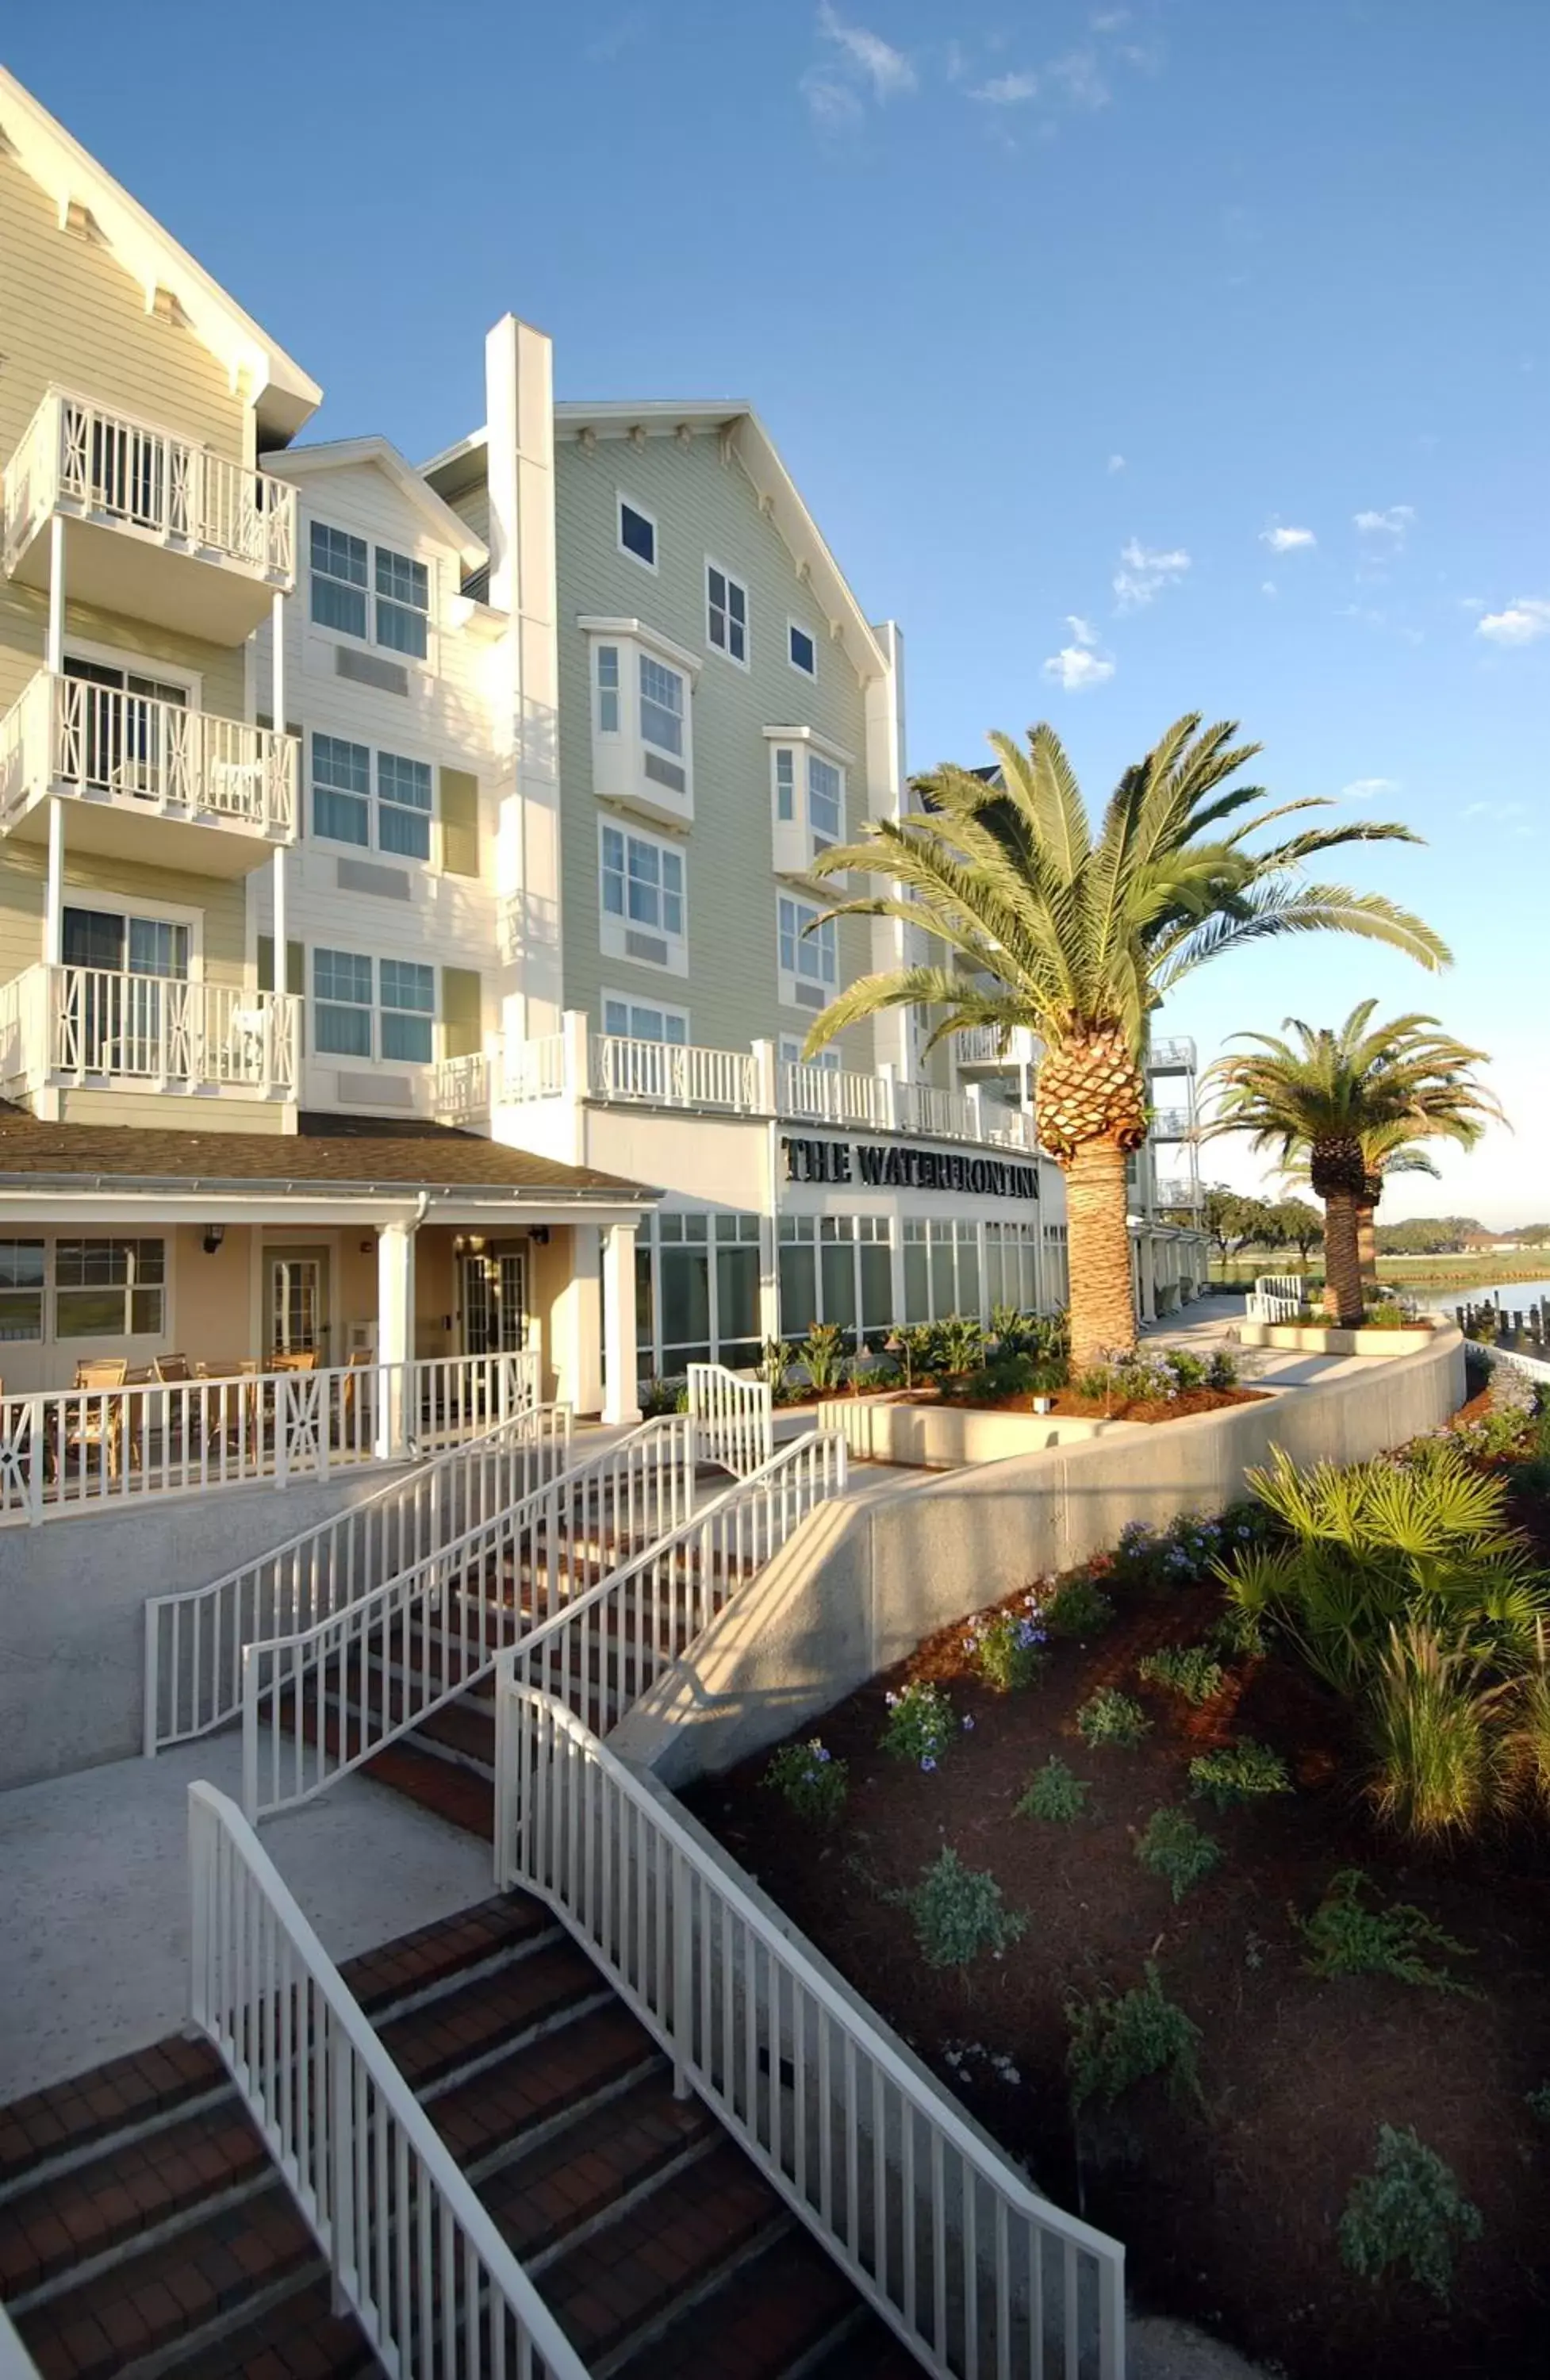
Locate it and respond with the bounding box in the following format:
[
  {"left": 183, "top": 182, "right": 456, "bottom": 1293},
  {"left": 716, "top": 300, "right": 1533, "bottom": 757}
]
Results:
[{"left": 0, "top": 67, "right": 324, "bottom": 440}]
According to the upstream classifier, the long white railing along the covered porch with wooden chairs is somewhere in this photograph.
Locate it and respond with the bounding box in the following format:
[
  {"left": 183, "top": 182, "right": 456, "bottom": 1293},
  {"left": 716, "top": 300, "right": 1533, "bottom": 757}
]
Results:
[{"left": 0, "top": 1349, "right": 538, "bottom": 1526}]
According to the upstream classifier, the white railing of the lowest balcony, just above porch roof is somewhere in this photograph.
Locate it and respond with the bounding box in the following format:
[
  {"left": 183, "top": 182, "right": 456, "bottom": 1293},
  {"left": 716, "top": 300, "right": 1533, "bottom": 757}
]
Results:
[{"left": 0, "top": 966, "right": 300, "bottom": 1100}]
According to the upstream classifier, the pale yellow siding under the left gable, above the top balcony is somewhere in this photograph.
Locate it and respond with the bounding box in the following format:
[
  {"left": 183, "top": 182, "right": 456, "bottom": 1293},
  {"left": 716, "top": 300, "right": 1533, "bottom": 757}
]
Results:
[{"left": 0, "top": 150, "right": 243, "bottom": 462}]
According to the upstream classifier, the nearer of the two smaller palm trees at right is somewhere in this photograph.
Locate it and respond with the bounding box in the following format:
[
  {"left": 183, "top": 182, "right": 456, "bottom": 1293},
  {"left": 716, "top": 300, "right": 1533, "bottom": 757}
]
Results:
[{"left": 1205, "top": 1000, "right": 1502, "bottom": 1326}]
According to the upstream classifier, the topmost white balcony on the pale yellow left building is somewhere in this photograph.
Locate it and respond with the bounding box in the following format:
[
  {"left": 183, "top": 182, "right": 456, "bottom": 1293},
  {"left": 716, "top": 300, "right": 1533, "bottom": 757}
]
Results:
[{"left": 0, "top": 388, "right": 295, "bottom": 645}]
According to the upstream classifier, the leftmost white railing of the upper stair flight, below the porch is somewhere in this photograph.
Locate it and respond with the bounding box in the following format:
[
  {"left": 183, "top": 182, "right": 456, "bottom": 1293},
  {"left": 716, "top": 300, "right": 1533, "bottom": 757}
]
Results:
[{"left": 145, "top": 1404, "right": 571, "bottom": 1759}]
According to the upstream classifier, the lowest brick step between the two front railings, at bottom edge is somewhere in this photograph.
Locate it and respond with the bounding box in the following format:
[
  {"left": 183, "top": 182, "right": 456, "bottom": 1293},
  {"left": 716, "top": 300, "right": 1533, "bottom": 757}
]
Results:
[{"left": 612, "top": 2223, "right": 881, "bottom": 2380}]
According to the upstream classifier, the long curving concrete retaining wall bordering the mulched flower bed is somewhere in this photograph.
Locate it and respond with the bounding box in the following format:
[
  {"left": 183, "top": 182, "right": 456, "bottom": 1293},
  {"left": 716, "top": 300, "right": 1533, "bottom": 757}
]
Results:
[{"left": 609, "top": 1330, "right": 1464, "bottom": 1785}]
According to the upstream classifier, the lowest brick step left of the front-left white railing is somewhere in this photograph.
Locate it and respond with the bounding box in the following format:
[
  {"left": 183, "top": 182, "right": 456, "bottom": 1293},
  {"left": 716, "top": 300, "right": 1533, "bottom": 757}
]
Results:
[{"left": 17, "top": 2175, "right": 321, "bottom": 2380}]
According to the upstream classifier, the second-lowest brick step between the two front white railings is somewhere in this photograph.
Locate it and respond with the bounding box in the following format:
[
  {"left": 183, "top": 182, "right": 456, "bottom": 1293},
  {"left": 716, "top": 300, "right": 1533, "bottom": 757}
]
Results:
[{"left": 540, "top": 2137, "right": 791, "bottom": 2380}]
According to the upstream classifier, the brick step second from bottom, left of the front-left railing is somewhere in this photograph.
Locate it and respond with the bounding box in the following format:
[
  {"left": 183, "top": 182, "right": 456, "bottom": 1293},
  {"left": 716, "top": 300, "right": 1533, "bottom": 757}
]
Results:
[{"left": 0, "top": 2092, "right": 271, "bottom": 2311}]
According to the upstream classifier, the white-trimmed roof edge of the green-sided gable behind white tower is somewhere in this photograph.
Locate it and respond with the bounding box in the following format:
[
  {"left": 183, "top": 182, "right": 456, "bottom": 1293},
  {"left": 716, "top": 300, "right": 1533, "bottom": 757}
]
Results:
[{"left": 421, "top": 397, "right": 888, "bottom": 678}]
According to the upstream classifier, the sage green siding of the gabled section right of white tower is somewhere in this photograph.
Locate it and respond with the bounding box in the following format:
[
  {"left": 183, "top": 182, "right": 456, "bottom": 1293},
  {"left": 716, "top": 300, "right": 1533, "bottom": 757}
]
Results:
[{"left": 554, "top": 431, "right": 874, "bottom": 1066}]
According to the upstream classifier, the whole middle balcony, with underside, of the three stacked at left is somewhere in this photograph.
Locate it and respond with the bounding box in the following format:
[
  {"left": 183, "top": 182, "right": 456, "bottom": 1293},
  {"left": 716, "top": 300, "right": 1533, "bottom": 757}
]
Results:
[{"left": 0, "top": 669, "right": 297, "bottom": 876}]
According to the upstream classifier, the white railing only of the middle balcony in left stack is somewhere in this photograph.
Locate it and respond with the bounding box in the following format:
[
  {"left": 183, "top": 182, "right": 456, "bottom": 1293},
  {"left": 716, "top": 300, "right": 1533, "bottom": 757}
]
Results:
[{"left": 0, "top": 669, "right": 297, "bottom": 843}]
